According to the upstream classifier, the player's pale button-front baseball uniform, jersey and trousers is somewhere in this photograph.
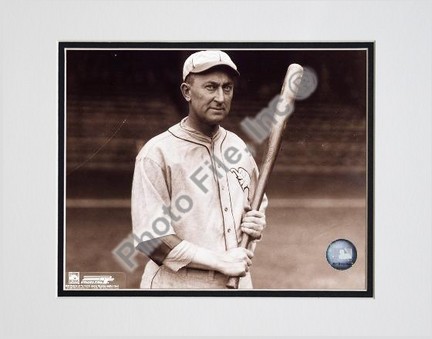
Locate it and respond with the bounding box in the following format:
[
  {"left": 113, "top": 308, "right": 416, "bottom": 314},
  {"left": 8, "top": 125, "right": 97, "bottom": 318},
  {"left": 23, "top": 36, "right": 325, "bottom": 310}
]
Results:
[{"left": 132, "top": 120, "right": 267, "bottom": 288}]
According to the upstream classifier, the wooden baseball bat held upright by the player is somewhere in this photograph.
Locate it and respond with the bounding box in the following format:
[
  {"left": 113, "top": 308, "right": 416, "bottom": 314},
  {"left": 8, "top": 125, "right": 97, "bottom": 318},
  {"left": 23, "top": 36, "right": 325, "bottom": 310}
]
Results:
[{"left": 226, "top": 64, "right": 303, "bottom": 289}]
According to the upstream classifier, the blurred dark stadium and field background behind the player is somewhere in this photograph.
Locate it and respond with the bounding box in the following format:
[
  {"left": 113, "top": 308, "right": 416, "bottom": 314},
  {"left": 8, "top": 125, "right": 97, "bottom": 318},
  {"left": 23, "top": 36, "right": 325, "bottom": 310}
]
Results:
[{"left": 65, "top": 49, "right": 367, "bottom": 290}]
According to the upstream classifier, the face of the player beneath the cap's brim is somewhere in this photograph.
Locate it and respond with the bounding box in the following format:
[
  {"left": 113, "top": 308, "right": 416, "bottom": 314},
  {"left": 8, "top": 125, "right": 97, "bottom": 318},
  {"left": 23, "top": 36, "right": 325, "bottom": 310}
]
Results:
[{"left": 185, "top": 70, "right": 234, "bottom": 126}]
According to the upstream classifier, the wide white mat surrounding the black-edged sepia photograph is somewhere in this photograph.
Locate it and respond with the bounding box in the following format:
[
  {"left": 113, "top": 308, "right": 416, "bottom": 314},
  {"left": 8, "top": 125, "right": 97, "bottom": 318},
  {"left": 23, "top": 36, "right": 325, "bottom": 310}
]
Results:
[{"left": 0, "top": 0, "right": 432, "bottom": 336}]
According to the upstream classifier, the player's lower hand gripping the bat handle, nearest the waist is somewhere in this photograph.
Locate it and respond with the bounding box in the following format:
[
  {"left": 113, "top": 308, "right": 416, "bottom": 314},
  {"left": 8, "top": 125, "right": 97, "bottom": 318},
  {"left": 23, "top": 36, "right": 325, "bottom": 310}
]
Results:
[{"left": 218, "top": 247, "right": 254, "bottom": 277}]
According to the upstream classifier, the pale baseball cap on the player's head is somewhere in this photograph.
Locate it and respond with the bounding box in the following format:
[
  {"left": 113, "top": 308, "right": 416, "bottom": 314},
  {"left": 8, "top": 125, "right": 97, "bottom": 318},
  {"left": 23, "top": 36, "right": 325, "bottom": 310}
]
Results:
[{"left": 183, "top": 50, "right": 240, "bottom": 80}]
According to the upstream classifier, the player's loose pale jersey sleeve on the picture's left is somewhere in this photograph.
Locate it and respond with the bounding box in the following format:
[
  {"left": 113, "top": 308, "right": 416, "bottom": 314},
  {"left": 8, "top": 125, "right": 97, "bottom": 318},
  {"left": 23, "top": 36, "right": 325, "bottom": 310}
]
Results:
[{"left": 131, "top": 157, "right": 175, "bottom": 247}]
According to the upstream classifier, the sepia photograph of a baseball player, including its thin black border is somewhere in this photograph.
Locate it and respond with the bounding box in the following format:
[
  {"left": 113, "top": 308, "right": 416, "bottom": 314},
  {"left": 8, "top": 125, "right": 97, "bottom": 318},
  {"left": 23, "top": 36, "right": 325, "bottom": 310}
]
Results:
[{"left": 57, "top": 42, "right": 375, "bottom": 297}]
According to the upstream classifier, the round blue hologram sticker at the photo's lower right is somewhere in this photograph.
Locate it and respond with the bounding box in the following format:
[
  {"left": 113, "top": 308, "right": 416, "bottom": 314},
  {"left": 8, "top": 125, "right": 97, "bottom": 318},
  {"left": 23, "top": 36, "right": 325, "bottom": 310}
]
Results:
[{"left": 326, "top": 239, "right": 357, "bottom": 270}]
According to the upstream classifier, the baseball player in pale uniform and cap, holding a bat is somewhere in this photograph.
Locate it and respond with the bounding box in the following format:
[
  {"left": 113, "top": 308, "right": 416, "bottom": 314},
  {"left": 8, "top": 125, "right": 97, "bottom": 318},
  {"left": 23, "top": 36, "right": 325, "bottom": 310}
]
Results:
[{"left": 132, "top": 50, "right": 267, "bottom": 289}]
